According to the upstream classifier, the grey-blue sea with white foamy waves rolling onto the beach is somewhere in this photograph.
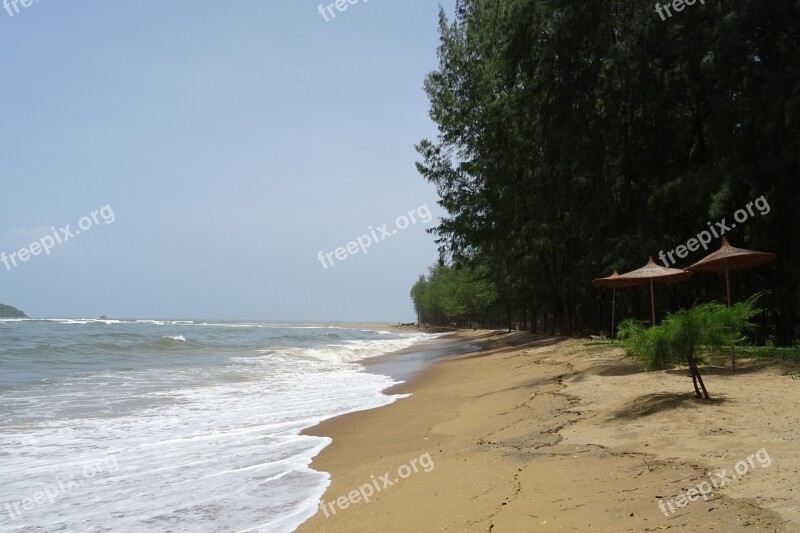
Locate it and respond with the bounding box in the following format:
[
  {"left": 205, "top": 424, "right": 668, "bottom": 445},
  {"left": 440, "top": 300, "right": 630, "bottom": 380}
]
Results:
[{"left": 0, "top": 319, "right": 454, "bottom": 533}]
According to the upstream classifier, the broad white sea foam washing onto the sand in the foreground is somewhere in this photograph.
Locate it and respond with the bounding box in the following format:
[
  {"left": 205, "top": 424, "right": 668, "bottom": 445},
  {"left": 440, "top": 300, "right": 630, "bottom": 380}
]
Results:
[{"left": 0, "top": 367, "right": 400, "bottom": 532}]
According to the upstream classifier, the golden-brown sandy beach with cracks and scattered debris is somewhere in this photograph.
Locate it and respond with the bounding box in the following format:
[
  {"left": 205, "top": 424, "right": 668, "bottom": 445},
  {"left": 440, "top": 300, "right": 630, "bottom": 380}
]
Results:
[{"left": 298, "top": 331, "right": 800, "bottom": 532}]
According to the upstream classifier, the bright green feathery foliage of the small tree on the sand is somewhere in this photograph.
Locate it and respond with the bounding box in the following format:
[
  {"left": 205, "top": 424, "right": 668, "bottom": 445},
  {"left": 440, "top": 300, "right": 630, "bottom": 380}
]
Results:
[{"left": 619, "top": 294, "right": 761, "bottom": 372}]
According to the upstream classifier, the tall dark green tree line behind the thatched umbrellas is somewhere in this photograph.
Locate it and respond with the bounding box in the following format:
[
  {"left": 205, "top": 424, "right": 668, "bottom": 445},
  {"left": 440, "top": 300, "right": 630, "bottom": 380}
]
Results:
[{"left": 412, "top": 0, "right": 800, "bottom": 346}]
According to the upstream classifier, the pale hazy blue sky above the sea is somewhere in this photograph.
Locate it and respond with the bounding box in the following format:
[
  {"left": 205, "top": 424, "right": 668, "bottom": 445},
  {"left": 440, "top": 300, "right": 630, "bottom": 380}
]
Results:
[{"left": 0, "top": 0, "right": 454, "bottom": 322}]
